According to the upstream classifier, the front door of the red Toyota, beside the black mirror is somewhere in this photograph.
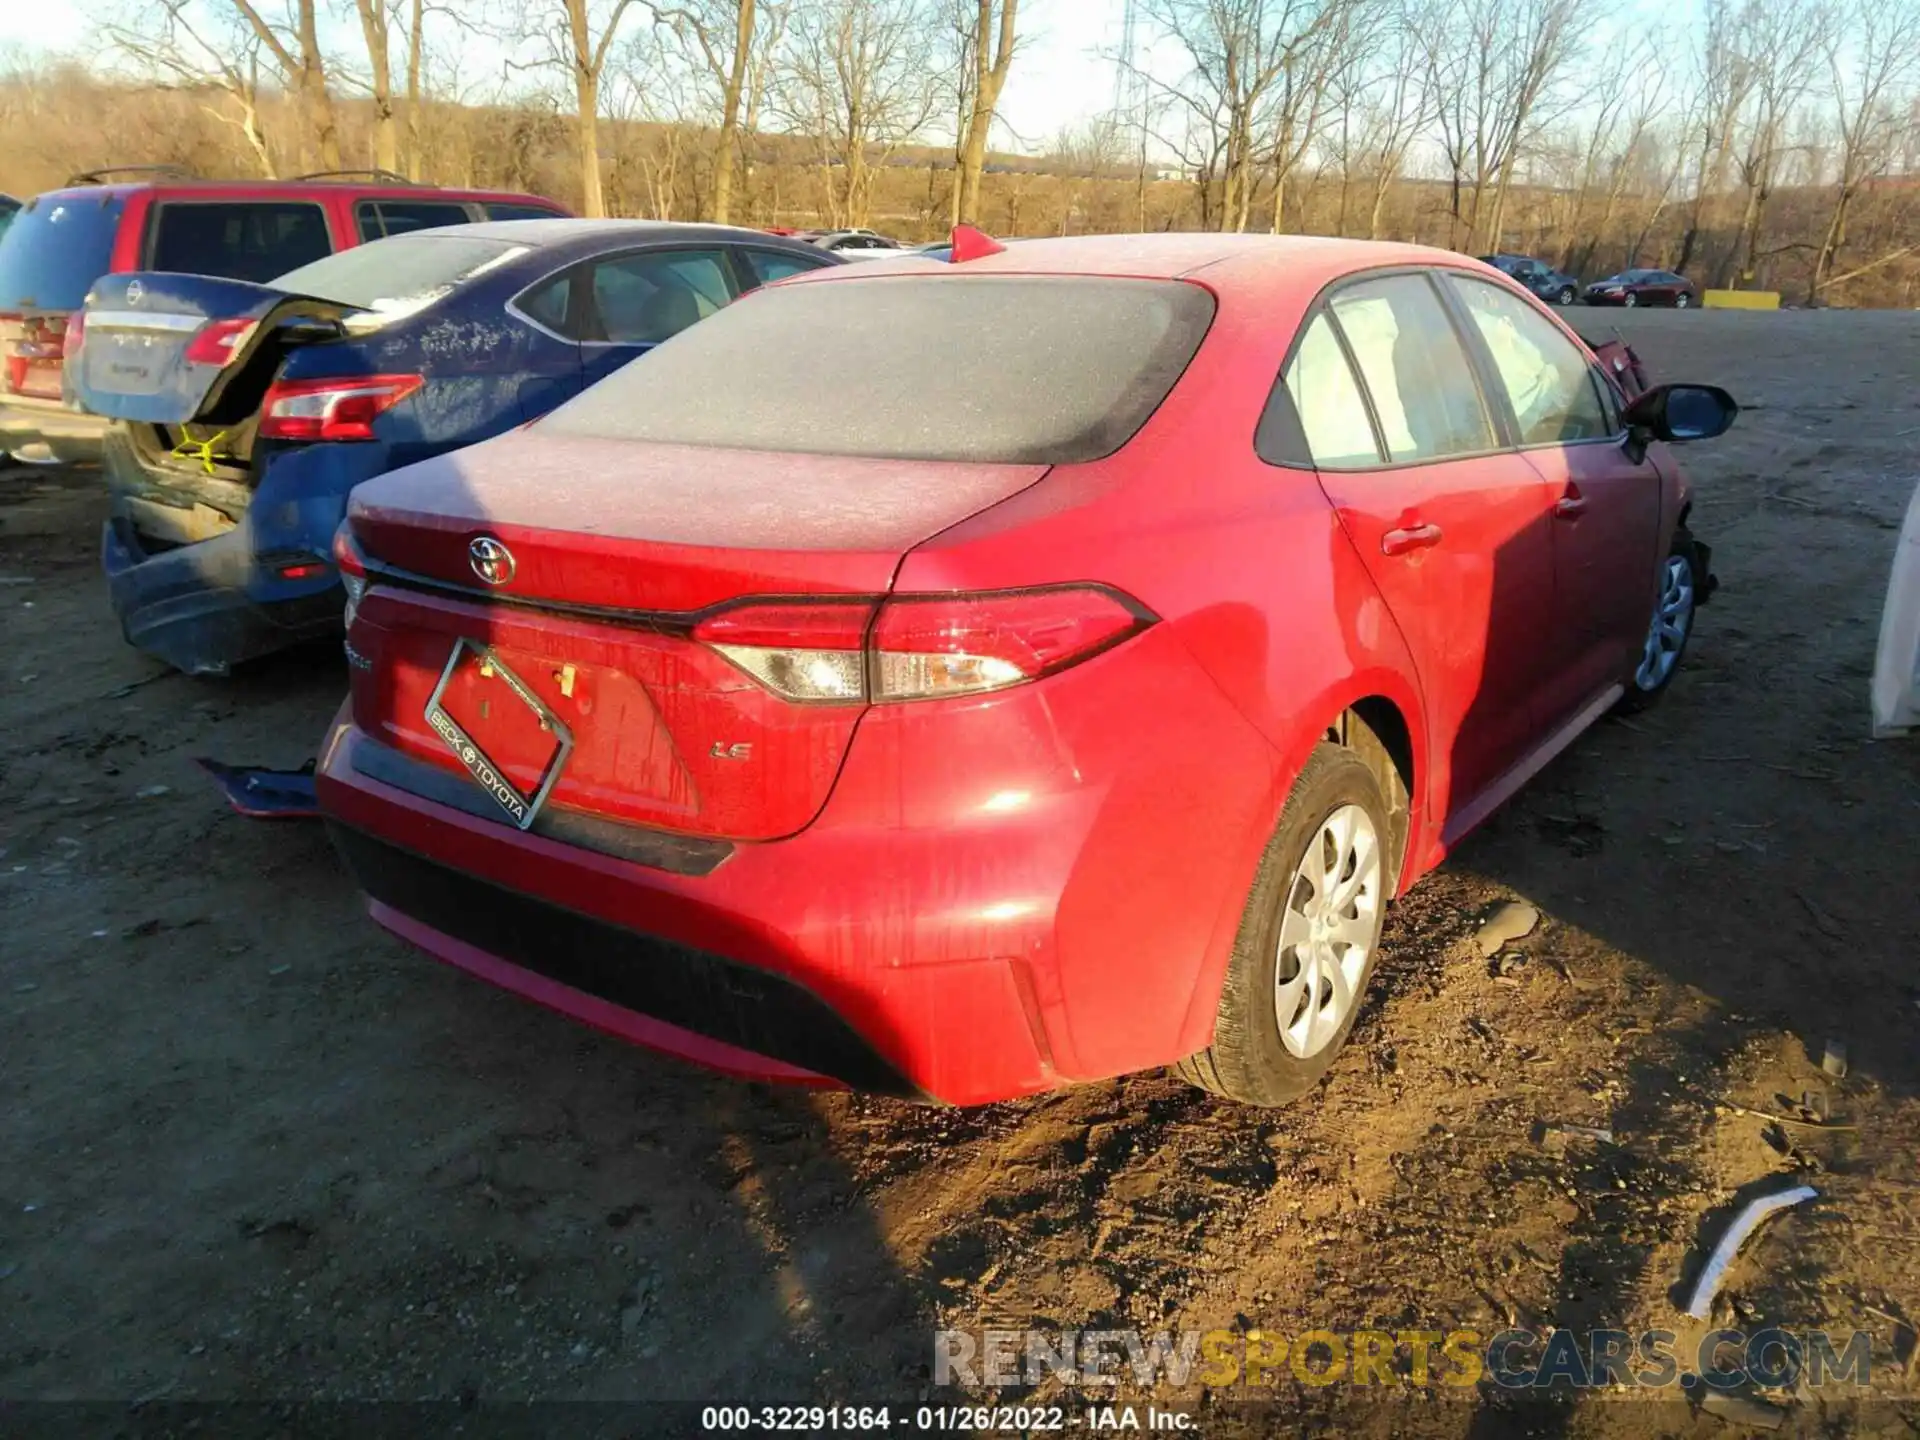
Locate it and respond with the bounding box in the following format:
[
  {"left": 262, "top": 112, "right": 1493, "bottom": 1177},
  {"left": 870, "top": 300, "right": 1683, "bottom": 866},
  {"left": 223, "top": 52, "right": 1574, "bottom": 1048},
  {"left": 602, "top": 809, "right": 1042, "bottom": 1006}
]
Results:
[{"left": 1448, "top": 275, "right": 1661, "bottom": 728}]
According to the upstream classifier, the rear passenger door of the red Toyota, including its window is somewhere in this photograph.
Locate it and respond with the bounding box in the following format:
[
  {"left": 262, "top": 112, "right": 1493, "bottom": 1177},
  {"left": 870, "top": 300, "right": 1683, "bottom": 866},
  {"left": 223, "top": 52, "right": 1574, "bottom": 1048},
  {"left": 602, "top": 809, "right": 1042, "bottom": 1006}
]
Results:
[{"left": 1286, "top": 273, "right": 1553, "bottom": 839}]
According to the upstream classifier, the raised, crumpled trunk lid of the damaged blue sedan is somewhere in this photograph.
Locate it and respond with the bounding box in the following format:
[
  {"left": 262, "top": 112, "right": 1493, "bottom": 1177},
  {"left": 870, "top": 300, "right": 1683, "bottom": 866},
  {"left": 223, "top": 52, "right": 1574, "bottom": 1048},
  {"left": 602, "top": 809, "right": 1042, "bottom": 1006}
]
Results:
[{"left": 65, "top": 271, "right": 351, "bottom": 426}]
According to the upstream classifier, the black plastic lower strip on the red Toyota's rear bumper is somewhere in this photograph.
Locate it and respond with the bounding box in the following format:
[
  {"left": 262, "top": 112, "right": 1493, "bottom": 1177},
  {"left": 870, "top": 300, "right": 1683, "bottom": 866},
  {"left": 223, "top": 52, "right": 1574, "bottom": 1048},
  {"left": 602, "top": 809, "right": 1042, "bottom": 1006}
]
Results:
[{"left": 326, "top": 820, "right": 929, "bottom": 1100}]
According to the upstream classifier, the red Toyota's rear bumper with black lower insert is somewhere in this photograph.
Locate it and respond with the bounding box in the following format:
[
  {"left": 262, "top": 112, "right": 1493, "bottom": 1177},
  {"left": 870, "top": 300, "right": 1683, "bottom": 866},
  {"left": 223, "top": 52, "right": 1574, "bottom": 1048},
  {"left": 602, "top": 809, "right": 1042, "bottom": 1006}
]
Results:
[{"left": 315, "top": 632, "right": 1279, "bottom": 1104}]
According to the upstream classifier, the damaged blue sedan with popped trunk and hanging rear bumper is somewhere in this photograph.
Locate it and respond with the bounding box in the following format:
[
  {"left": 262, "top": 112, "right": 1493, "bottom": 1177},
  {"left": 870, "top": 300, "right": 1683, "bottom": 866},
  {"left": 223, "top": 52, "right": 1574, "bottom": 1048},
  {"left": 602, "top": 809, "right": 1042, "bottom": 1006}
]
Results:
[{"left": 63, "top": 219, "right": 841, "bottom": 676}]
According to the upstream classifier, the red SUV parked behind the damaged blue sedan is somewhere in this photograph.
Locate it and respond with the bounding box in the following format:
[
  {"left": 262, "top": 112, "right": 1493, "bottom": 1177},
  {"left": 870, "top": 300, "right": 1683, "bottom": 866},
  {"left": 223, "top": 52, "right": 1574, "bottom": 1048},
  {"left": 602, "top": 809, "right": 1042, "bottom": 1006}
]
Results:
[{"left": 0, "top": 167, "right": 566, "bottom": 461}]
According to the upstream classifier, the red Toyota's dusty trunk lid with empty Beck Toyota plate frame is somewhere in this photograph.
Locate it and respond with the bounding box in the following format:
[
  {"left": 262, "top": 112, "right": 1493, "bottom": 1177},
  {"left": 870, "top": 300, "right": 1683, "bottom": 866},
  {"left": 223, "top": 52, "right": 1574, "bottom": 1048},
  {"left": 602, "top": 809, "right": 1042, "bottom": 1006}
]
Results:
[{"left": 337, "top": 426, "right": 1048, "bottom": 841}]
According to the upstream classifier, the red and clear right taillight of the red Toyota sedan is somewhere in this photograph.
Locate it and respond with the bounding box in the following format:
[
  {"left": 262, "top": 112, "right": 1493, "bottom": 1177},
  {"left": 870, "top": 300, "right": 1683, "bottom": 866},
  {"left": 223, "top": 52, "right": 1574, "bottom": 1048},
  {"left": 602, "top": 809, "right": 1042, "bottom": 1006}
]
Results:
[{"left": 693, "top": 586, "right": 1156, "bottom": 705}]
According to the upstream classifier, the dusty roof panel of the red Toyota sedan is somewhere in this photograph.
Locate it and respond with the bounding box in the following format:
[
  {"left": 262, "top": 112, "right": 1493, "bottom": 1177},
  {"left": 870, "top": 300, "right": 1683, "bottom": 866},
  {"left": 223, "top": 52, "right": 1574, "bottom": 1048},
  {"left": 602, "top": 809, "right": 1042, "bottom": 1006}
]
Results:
[{"left": 789, "top": 232, "right": 1475, "bottom": 288}]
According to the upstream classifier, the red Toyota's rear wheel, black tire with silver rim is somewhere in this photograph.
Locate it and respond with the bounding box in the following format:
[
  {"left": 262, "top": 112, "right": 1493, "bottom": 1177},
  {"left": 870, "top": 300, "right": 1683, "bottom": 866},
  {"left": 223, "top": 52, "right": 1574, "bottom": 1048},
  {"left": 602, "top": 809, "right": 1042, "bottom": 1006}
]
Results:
[{"left": 1175, "top": 743, "right": 1398, "bottom": 1106}]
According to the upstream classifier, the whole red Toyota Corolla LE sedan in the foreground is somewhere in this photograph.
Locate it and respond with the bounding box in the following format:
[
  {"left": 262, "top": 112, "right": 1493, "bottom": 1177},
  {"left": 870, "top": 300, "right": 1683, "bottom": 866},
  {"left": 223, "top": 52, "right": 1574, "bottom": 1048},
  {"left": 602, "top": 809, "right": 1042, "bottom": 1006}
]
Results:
[{"left": 319, "top": 234, "right": 1736, "bottom": 1104}]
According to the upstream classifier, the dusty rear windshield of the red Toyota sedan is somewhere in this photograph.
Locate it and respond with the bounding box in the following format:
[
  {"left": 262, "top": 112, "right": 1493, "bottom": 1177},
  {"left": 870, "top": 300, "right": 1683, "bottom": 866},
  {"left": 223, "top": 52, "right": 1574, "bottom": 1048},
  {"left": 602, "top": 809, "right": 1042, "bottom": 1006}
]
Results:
[{"left": 541, "top": 275, "right": 1213, "bottom": 465}]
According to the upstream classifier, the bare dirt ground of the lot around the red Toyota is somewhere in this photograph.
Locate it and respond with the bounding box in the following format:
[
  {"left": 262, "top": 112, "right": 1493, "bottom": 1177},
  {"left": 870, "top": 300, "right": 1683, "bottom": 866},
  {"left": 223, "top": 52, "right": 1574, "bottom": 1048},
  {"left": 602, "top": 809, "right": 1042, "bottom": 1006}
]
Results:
[{"left": 0, "top": 313, "right": 1920, "bottom": 1436}]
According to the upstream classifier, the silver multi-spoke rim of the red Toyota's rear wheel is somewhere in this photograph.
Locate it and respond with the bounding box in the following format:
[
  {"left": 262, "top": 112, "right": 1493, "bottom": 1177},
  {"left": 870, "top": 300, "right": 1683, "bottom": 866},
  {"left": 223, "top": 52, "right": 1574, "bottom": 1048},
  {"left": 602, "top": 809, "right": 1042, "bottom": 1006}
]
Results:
[{"left": 1273, "top": 804, "right": 1386, "bottom": 1060}]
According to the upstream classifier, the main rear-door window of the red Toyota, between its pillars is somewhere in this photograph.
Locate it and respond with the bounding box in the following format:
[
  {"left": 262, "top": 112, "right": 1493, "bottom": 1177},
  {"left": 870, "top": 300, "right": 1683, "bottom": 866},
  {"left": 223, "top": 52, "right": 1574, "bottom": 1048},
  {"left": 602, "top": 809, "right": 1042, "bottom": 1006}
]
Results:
[{"left": 1332, "top": 275, "right": 1498, "bottom": 461}]
